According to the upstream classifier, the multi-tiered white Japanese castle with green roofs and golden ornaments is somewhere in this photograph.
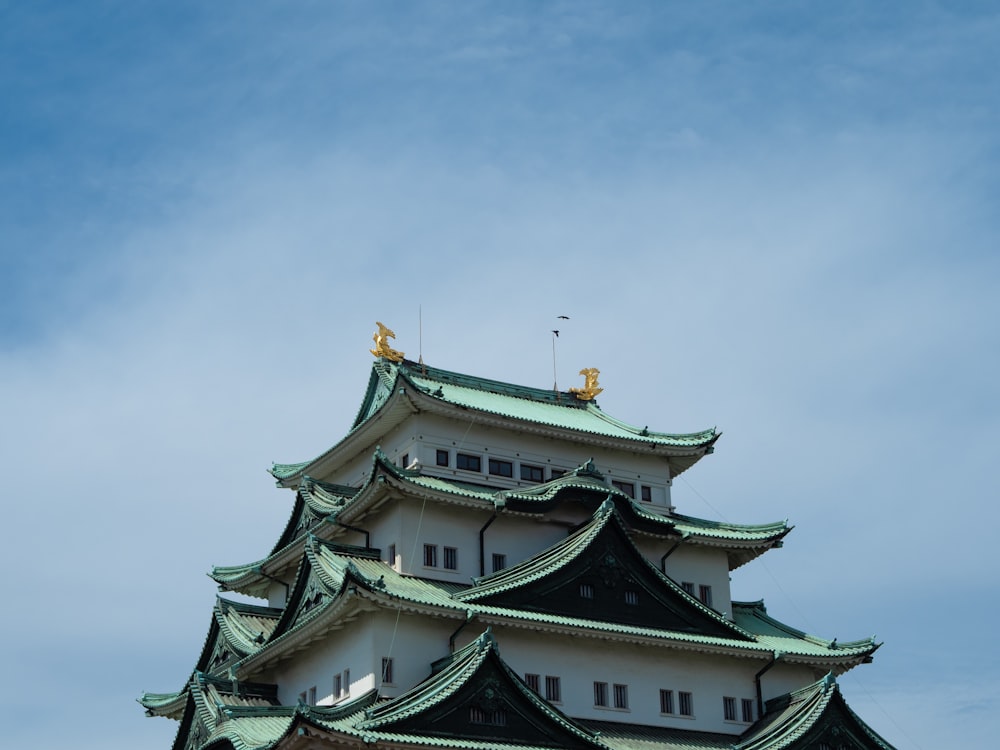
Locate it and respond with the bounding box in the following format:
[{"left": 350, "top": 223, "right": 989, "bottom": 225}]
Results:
[{"left": 139, "top": 334, "right": 890, "bottom": 750}]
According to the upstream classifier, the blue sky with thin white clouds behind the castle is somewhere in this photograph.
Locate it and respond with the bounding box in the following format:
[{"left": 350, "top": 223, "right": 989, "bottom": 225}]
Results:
[{"left": 0, "top": 2, "right": 1000, "bottom": 750}]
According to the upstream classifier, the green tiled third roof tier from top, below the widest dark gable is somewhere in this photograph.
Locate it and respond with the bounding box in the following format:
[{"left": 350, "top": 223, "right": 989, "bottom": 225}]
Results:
[{"left": 229, "top": 516, "right": 878, "bottom": 674}]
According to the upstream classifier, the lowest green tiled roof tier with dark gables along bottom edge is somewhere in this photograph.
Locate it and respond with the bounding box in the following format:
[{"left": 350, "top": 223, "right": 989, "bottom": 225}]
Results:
[{"left": 144, "top": 648, "right": 893, "bottom": 750}]
